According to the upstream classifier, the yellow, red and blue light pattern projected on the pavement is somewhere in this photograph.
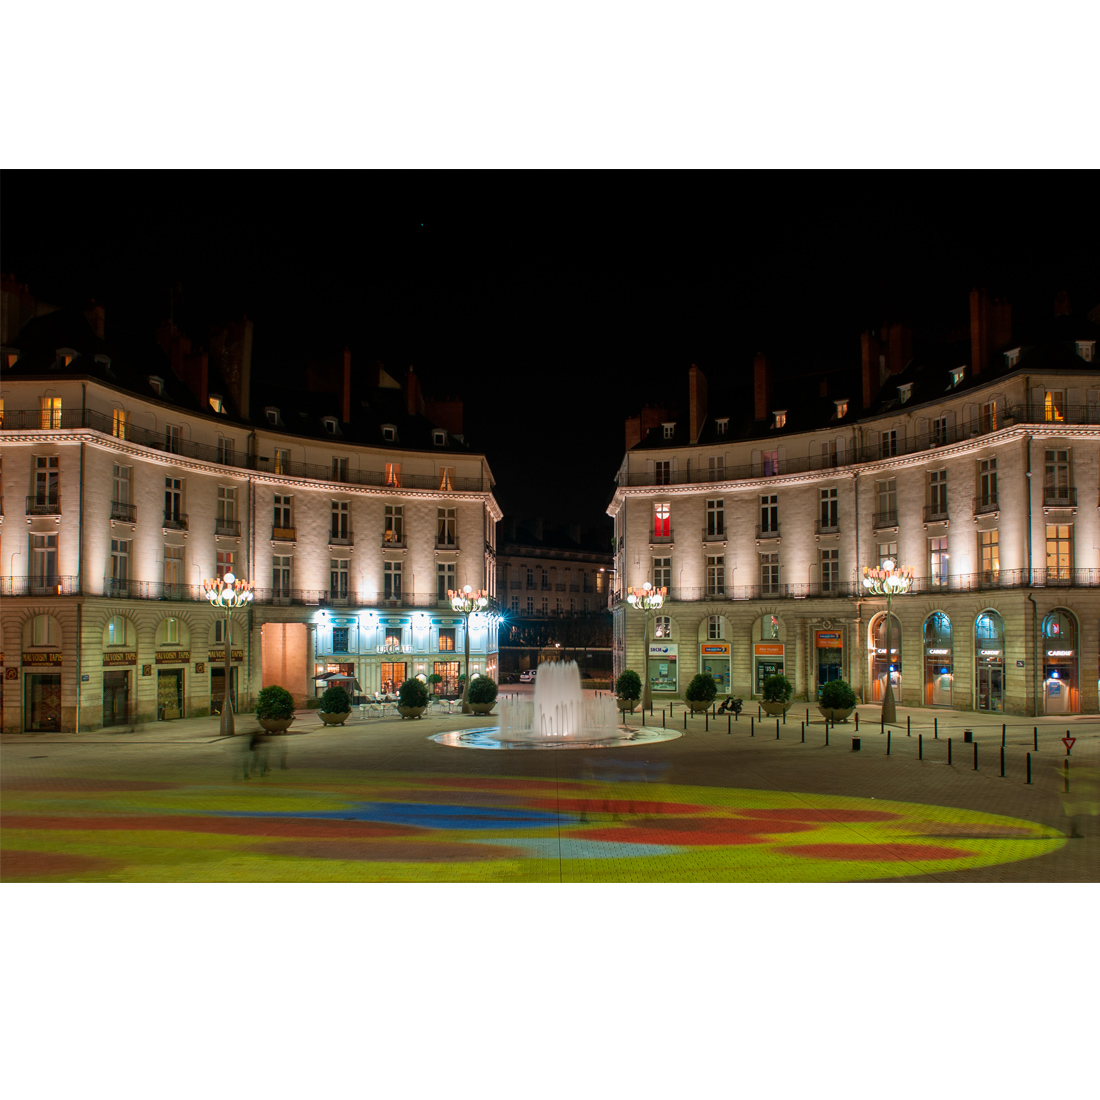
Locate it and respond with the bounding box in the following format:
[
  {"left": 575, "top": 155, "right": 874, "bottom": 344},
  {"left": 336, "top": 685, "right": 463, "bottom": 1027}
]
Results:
[{"left": 0, "top": 771, "right": 1066, "bottom": 882}]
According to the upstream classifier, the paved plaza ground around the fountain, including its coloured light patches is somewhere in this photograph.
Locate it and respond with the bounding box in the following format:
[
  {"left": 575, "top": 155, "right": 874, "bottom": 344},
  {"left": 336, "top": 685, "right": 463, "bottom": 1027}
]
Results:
[{"left": 0, "top": 703, "right": 1100, "bottom": 882}]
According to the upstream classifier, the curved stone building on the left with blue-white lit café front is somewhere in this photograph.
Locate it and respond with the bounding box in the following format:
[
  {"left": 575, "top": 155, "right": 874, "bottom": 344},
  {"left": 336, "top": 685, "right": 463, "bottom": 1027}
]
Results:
[{"left": 0, "top": 281, "right": 501, "bottom": 732}]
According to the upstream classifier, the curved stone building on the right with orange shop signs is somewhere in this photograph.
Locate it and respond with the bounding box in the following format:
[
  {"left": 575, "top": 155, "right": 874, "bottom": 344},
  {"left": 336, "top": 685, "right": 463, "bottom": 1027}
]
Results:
[{"left": 608, "top": 290, "right": 1100, "bottom": 714}]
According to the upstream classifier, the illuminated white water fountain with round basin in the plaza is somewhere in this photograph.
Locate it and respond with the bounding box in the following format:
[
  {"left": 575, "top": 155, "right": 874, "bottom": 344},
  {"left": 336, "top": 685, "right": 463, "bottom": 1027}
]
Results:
[{"left": 431, "top": 661, "right": 680, "bottom": 749}]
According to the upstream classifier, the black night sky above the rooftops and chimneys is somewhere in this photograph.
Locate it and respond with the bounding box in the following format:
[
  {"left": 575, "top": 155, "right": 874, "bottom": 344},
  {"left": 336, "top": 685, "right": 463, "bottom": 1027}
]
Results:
[{"left": 0, "top": 173, "right": 1100, "bottom": 525}]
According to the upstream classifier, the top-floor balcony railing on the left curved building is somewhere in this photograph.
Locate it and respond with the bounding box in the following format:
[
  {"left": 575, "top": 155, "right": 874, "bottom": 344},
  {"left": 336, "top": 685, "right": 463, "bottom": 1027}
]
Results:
[{"left": 0, "top": 409, "right": 492, "bottom": 493}]
